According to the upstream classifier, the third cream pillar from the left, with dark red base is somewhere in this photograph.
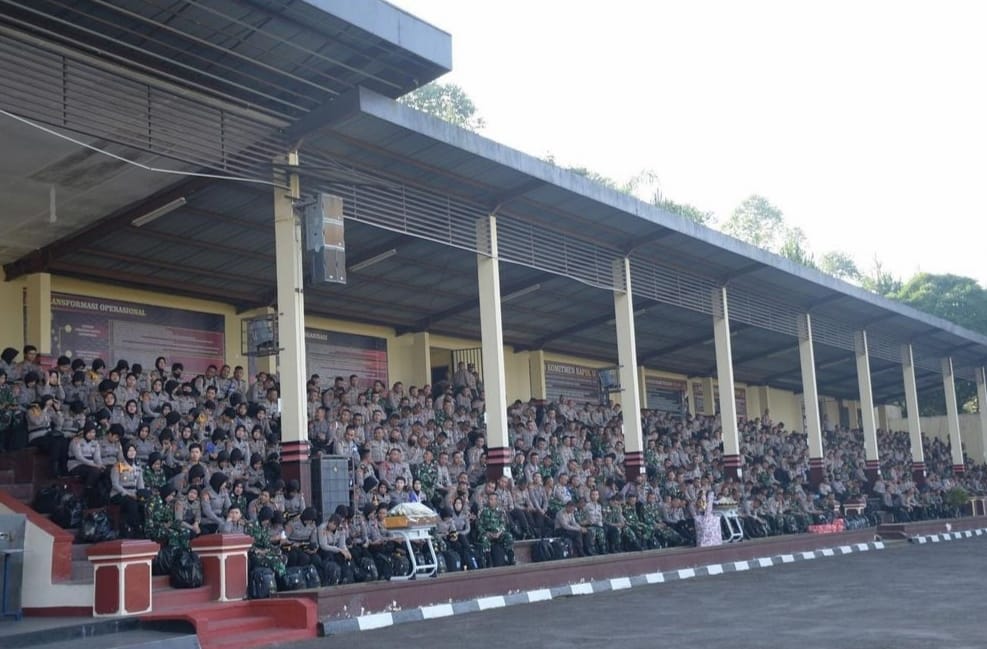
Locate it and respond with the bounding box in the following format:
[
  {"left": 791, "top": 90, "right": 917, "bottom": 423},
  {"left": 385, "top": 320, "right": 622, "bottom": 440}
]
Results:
[{"left": 613, "top": 257, "right": 644, "bottom": 480}]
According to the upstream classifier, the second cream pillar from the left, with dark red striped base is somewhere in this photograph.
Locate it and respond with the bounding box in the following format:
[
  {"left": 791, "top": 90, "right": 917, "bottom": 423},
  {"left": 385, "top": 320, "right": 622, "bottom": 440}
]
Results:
[{"left": 476, "top": 214, "right": 514, "bottom": 479}]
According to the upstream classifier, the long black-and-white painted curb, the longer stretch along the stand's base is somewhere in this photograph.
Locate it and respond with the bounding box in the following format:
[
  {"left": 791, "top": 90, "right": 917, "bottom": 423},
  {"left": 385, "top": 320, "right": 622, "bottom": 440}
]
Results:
[{"left": 323, "top": 541, "right": 885, "bottom": 636}]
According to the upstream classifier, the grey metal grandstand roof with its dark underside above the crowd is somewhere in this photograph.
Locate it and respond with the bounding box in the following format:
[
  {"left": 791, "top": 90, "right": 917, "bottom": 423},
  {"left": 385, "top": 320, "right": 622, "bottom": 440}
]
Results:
[{"left": 0, "top": 5, "right": 987, "bottom": 401}]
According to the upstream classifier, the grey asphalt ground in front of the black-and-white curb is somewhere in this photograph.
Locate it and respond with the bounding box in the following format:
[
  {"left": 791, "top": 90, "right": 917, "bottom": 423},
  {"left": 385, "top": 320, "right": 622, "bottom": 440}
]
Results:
[{"left": 302, "top": 537, "right": 987, "bottom": 649}]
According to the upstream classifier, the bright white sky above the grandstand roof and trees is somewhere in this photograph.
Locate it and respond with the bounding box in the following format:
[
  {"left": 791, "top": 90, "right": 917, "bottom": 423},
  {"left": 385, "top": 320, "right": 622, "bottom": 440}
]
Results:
[{"left": 390, "top": 0, "right": 987, "bottom": 286}]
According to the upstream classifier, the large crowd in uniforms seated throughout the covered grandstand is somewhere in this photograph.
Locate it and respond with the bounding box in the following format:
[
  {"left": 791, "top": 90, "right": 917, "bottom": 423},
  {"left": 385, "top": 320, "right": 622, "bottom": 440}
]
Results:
[{"left": 0, "top": 346, "right": 987, "bottom": 584}]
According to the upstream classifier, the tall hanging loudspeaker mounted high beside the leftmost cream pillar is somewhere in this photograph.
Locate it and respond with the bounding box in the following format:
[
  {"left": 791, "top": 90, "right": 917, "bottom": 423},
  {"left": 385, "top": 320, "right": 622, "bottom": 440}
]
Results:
[{"left": 302, "top": 194, "right": 346, "bottom": 286}]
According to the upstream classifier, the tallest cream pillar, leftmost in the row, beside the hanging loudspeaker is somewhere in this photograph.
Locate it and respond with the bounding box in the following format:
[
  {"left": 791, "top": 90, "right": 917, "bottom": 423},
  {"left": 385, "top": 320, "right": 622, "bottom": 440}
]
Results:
[{"left": 274, "top": 153, "right": 310, "bottom": 502}]
